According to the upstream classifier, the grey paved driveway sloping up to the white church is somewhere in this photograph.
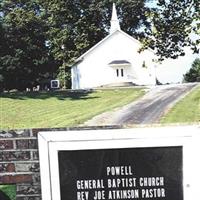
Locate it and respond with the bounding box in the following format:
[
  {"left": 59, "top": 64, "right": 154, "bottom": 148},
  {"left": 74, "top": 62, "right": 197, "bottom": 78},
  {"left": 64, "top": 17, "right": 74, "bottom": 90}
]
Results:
[{"left": 84, "top": 83, "right": 197, "bottom": 126}]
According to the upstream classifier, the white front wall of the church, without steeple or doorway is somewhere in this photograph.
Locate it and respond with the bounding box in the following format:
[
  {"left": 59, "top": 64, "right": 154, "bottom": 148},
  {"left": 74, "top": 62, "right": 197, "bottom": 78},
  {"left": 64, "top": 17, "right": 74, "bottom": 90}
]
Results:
[{"left": 72, "top": 31, "right": 155, "bottom": 89}]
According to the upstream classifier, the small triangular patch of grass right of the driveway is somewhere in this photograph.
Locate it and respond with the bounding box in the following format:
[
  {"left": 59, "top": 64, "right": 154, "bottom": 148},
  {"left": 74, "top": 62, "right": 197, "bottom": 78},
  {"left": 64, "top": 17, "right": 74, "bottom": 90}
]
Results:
[{"left": 161, "top": 87, "right": 200, "bottom": 123}]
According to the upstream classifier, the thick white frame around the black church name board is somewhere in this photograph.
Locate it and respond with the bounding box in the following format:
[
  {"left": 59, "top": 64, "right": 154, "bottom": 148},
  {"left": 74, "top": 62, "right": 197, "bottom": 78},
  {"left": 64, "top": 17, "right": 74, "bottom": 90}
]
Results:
[{"left": 38, "top": 126, "right": 200, "bottom": 200}]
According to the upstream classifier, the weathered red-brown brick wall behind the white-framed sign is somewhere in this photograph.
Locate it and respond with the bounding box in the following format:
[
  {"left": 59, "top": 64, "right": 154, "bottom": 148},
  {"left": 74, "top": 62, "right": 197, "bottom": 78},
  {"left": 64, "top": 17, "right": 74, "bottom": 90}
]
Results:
[{"left": 0, "top": 126, "right": 122, "bottom": 200}]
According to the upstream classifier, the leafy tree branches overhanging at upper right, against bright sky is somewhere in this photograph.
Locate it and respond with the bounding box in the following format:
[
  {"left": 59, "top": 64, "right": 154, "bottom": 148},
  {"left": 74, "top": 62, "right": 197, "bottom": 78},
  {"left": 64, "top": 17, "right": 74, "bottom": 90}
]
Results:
[{"left": 143, "top": 0, "right": 200, "bottom": 60}]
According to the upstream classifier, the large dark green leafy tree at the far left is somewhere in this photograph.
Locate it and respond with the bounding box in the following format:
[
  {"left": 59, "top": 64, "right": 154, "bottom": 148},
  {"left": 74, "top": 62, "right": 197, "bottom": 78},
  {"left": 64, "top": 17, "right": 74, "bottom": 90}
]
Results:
[{"left": 0, "top": 0, "right": 58, "bottom": 90}]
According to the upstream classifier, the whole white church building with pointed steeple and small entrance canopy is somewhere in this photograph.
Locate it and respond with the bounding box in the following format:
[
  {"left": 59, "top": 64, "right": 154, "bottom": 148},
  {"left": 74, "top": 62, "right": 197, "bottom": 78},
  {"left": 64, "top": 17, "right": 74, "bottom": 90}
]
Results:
[{"left": 71, "top": 4, "right": 156, "bottom": 89}]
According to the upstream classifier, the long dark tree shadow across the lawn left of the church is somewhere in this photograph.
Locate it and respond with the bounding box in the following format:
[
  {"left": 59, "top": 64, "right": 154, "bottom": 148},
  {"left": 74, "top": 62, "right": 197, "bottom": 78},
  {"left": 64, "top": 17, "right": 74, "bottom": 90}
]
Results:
[{"left": 1, "top": 90, "right": 98, "bottom": 100}]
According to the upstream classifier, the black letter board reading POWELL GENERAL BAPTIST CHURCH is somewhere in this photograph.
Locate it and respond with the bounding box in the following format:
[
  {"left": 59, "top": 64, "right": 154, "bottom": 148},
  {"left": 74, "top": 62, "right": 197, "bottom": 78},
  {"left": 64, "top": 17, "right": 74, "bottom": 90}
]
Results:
[{"left": 58, "top": 146, "right": 183, "bottom": 200}]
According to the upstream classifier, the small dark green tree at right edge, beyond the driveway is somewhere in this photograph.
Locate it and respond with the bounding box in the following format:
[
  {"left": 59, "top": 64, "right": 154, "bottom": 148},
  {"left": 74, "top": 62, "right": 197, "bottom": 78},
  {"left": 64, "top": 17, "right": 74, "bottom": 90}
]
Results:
[{"left": 184, "top": 58, "right": 200, "bottom": 82}]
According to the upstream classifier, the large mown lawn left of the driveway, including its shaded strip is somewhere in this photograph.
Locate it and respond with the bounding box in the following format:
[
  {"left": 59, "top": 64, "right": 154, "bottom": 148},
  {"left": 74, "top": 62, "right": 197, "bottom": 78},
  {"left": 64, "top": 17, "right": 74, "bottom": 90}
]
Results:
[{"left": 0, "top": 88, "right": 144, "bottom": 130}]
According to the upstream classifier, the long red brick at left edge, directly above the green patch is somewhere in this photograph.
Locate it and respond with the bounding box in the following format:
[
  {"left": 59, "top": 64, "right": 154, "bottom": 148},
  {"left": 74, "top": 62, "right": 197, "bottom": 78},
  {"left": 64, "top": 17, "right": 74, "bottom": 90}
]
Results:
[{"left": 0, "top": 175, "right": 32, "bottom": 184}]
